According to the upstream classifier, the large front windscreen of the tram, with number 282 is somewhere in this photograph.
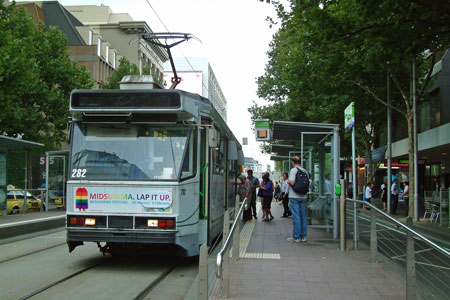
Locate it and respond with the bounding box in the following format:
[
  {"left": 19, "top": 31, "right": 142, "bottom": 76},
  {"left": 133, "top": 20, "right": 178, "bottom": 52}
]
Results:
[{"left": 70, "top": 122, "right": 195, "bottom": 180}]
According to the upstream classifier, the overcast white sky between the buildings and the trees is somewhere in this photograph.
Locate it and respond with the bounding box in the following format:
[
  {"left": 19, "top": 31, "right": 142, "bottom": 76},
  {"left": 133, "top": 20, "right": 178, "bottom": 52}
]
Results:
[{"left": 38, "top": 0, "right": 284, "bottom": 170}]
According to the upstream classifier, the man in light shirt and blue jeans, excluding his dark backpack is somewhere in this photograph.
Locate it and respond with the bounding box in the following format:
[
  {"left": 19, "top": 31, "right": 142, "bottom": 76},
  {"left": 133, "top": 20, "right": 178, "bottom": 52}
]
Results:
[{"left": 287, "top": 156, "right": 309, "bottom": 243}]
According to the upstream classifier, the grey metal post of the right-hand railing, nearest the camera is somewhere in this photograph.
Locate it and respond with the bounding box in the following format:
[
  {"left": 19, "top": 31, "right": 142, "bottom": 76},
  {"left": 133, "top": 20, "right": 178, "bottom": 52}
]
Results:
[{"left": 406, "top": 217, "right": 417, "bottom": 300}]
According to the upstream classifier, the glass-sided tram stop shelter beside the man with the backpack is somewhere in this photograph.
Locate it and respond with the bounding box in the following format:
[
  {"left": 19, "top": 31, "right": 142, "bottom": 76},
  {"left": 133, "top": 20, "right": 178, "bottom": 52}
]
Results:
[{"left": 271, "top": 121, "right": 340, "bottom": 238}]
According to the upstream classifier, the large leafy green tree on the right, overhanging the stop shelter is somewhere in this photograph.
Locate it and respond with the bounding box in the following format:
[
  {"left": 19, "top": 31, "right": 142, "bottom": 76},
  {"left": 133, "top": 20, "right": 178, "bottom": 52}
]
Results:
[{"left": 251, "top": 0, "right": 450, "bottom": 215}]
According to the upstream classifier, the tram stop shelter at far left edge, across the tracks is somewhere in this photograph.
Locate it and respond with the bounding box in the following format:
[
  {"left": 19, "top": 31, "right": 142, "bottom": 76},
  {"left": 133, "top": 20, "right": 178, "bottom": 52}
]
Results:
[{"left": 0, "top": 135, "right": 44, "bottom": 215}]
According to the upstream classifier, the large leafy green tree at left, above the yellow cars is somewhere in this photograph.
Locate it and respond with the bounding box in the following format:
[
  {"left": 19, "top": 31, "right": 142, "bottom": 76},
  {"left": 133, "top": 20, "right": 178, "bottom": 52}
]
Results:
[{"left": 0, "top": 1, "right": 92, "bottom": 149}]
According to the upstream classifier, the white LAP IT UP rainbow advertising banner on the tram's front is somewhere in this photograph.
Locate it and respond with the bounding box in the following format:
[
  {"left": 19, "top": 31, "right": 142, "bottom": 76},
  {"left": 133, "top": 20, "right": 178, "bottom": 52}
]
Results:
[{"left": 72, "top": 186, "right": 172, "bottom": 214}]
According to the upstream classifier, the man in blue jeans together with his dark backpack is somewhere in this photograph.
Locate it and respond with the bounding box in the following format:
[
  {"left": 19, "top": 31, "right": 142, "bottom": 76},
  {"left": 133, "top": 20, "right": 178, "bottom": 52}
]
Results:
[{"left": 287, "top": 156, "right": 309, "bottom": 243}]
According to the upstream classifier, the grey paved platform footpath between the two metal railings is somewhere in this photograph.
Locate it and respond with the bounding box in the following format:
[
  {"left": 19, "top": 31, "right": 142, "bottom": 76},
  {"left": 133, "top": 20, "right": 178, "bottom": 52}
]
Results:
[{"left": 218, "top": 202, "right": 406, "bottom": 300}]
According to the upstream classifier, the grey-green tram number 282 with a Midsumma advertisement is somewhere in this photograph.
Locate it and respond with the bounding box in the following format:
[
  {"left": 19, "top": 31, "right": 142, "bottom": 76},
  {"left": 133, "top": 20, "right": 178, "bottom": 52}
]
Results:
[{"left": 66, "top": 77, "right": 244, "bottom": 256}]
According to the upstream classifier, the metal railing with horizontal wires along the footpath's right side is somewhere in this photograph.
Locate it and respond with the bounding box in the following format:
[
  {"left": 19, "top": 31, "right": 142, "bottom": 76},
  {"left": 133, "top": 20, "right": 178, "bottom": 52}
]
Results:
[{"left": 340, "top": 198, "right": 450, "bottom": 300}]
